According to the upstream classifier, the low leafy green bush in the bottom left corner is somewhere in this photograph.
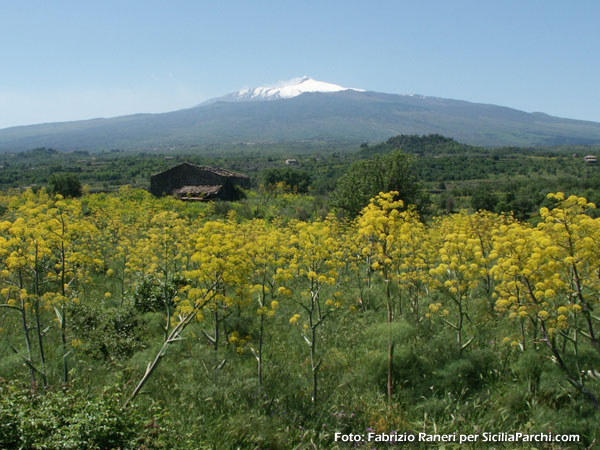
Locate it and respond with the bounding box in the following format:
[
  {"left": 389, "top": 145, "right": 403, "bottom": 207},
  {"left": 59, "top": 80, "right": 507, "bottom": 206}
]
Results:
[{"left": 0, "top": 382, "right": 163, "bottom": 450}]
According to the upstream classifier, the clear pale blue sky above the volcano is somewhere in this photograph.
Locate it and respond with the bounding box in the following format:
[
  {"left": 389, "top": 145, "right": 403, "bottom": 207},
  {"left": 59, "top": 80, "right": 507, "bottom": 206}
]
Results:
[{"left": 0, "top": 0, "right": 600, "bottom": 128}]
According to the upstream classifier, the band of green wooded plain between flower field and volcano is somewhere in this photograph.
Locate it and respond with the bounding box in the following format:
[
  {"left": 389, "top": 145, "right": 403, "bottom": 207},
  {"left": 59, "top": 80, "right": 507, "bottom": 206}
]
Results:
[{"left": 0, "top": 135, "right": 600, "bottom": 219}]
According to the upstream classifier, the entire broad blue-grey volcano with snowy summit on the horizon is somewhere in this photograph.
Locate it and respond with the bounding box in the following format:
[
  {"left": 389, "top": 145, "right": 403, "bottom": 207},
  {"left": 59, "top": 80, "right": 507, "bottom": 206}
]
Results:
[{"left": 0, "top": 77, "right": 600, "bottom": 152}]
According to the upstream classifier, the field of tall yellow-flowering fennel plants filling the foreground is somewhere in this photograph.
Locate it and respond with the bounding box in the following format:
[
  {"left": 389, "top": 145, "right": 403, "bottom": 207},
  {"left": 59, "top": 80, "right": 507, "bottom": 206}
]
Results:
[{"left": 0, "top": 188, "right": 600, "bottom": 448}]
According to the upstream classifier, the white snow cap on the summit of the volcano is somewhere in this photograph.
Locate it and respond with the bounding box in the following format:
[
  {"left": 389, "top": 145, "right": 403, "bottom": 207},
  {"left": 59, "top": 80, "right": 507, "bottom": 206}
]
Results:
[{"left": 208, "top": 76, "right": 364, "bottom": 103}]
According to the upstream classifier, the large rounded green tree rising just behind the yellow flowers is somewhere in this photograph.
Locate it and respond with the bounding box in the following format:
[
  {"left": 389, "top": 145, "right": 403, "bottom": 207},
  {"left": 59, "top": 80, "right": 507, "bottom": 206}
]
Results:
[{"left": 333, "top": 150, "right": 428, "bottom": 217}]
